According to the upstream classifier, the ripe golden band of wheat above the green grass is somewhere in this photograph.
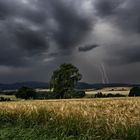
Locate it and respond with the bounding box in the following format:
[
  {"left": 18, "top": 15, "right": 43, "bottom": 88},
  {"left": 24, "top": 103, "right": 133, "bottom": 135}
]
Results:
[{"left": 0, "top": 98, "right": 140, "bottom": 126}]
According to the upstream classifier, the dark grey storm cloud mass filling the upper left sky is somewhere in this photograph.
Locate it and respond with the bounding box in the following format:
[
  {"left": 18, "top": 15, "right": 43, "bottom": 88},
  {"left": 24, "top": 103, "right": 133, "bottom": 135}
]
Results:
[{"left": 0, "top": 0, "right": 48, "bottom": 67}]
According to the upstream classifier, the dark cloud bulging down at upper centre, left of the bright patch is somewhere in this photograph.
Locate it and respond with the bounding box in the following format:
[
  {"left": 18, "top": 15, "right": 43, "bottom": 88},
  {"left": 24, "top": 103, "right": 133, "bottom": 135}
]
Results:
[{"left": 51, "top": 0, "right": 92, "bottom": 49}]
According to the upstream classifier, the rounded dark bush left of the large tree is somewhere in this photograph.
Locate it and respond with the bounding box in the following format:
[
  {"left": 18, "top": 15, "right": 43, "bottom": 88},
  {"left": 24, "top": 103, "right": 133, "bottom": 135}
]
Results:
[{"left": 16, "top": 87, "right": 37, "bottom": 100}]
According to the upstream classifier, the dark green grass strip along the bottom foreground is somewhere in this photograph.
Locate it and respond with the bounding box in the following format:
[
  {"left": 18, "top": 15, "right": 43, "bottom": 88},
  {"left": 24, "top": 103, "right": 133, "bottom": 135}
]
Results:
[{"left": 0, "top": 121, "right": 140, "bottom": 140}]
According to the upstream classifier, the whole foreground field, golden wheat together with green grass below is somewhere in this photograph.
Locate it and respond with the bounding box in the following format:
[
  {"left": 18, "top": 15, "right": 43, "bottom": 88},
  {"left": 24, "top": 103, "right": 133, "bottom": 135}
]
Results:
[{"left": 0, "top": 97, "right": 140, "bottom": 140}]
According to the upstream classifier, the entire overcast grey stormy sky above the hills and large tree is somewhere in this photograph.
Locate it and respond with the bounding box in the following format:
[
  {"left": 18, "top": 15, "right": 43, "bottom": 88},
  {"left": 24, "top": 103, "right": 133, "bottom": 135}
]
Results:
[{"left": 0, "top": 0, "right": 140, "bottom": 83}]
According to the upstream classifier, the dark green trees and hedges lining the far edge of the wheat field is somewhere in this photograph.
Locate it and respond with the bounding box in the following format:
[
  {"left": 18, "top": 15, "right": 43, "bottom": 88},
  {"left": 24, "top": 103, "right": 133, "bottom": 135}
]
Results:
[{"left": 0, "top": 64, "right": 140, "bottom": 101}]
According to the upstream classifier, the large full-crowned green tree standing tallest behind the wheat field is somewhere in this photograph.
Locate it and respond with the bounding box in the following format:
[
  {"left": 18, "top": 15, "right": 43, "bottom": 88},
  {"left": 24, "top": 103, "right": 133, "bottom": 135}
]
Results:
[{"left": 50, "top": 64, "right": 82, "bottom": 98}]
